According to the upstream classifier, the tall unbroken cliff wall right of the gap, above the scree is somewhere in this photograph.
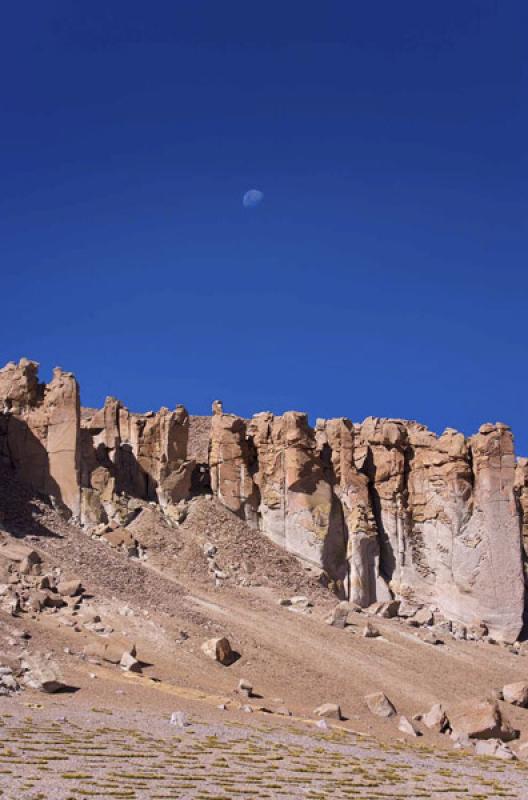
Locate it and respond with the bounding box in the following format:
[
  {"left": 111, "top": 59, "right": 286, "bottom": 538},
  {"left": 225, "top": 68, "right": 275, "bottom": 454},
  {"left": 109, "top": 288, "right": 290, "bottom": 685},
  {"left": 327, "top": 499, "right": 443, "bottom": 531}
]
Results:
[{"left": 211, "top": 409, "right": 525, "bottom": 641}]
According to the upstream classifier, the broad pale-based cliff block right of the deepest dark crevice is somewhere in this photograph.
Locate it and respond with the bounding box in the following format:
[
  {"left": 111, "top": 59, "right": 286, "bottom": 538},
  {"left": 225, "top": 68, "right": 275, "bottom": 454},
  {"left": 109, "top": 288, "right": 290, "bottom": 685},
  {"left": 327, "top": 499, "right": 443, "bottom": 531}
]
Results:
[{"left": 354, "top": 420, "right": 524, "bottom": 639}]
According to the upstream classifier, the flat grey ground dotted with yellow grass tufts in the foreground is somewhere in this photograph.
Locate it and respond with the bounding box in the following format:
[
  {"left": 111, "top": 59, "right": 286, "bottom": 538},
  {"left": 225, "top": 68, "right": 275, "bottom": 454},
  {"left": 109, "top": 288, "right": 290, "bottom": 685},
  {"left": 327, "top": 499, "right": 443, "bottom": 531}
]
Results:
[{"left": 0, "top": 702, "right": 528, "bottom": 800}]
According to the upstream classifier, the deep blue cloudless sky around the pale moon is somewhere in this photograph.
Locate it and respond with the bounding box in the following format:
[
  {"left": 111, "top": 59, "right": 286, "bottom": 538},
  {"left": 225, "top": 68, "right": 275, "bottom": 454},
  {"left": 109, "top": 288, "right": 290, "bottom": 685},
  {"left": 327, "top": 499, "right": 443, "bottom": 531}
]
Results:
[{"left": 0, "top": 0, "right": 528, "bottom": 454}]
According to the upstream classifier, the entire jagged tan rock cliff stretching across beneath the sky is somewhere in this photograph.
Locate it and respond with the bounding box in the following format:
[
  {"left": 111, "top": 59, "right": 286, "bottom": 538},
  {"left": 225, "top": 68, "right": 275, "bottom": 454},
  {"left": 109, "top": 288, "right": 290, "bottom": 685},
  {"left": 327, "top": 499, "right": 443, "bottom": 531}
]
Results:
[{"left": 0, "top": 359, "right": 528, "bottom": 641}]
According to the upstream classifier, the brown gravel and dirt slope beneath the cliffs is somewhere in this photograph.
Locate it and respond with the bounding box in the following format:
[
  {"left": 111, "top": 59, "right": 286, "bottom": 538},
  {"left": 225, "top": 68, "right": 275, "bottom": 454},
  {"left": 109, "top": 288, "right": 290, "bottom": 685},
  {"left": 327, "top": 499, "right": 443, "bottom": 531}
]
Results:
[{"left": 0, "top": 468, "right": 528, "bottom": 746}]
